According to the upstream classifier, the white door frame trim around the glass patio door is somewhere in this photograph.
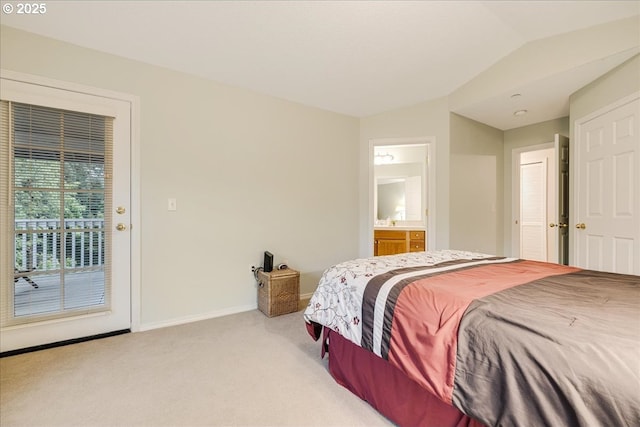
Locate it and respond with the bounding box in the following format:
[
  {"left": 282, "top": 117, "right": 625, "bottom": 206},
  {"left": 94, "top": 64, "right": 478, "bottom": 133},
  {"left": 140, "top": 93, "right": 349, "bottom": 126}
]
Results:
[{"left": 0, "top": 69, "right": 141, "bottom": 332}]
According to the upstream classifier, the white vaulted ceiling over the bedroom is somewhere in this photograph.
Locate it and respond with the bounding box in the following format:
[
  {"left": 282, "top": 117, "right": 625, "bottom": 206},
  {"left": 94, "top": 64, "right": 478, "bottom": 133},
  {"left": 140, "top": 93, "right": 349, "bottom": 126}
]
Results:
[{"left": 0, "top": 1, "right": 640, "bottom": 129}]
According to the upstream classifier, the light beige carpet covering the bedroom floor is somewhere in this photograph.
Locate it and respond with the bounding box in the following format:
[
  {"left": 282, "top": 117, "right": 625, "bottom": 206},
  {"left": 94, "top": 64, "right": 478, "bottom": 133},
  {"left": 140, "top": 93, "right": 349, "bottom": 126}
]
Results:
[{"left": 0, "top": 310, "right": 393, "bottom": 427}]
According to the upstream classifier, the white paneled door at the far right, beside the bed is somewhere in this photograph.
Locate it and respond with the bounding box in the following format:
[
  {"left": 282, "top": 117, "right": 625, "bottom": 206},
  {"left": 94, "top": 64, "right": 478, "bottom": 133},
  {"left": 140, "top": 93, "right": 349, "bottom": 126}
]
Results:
[{"left": 573, "top": 95, "right": 640, "bottom": 274}]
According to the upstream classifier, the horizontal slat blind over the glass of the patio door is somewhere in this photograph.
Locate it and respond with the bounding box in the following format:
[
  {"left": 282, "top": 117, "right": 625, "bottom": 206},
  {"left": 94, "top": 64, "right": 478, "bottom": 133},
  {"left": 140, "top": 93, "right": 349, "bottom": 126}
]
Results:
[{"left": 0, "top": 101, "right": 113, "bottom": 326}]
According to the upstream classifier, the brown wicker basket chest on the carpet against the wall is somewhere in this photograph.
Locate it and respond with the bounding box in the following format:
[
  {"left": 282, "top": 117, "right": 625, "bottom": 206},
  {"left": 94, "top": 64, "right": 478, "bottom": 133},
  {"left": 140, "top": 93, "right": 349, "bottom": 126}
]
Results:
[{"left": 258, "top": 269, "right": 300, "bottom": 317}]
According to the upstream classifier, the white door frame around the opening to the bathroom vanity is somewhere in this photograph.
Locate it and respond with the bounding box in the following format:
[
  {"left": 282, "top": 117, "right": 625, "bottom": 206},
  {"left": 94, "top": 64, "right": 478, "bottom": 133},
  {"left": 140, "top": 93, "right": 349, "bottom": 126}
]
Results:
[{"left": 367, "top": 136, "right": 436, "bottom": 256}]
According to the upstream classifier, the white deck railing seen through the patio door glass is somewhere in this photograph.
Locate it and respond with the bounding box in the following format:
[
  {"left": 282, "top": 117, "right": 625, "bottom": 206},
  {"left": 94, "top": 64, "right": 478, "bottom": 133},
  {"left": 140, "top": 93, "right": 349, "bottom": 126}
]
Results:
[{"left": 15, "top": 218, "right": 105, "bottom": 271}]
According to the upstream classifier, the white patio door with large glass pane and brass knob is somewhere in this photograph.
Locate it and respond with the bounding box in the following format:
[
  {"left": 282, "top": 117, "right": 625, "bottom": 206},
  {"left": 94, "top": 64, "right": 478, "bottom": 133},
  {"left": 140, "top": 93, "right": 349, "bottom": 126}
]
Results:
[{"left": 0, "top": 74, "right": 131, "bottom": 352}]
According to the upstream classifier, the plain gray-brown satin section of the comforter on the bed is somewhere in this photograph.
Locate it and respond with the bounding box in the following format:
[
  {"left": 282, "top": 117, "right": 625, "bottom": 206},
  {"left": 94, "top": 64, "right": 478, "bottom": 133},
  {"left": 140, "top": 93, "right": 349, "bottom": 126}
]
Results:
[{"left": 452, "top": 270, "right": 640, "bottom": 427}]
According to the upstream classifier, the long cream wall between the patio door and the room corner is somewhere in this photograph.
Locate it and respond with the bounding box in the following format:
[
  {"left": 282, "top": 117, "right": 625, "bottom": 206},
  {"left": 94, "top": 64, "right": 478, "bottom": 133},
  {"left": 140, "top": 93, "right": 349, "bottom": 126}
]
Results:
[{"left": 0, "top": 27, "right": 360, "bottom": 328}]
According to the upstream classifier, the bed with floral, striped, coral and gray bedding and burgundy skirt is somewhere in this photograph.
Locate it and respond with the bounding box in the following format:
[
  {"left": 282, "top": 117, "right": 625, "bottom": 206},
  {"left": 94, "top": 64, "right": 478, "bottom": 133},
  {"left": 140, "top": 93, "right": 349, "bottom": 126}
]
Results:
[{"left": 304, "top": 250, "right": 640, "bottom": 427}]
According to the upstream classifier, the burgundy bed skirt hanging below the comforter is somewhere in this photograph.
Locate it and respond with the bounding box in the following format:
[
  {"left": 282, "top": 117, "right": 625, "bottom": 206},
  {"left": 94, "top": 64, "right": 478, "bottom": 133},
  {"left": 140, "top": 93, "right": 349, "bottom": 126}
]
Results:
[{"left": 323, "top": 328, "right": 483, "bottom": 427}]
